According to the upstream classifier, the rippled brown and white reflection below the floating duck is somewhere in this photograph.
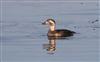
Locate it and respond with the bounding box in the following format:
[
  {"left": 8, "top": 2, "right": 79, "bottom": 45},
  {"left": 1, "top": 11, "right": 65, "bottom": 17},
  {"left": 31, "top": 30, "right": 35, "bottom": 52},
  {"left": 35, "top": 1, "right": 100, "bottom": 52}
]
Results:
[{"left": 43, "top": 36, "right": 66, "bottom": 54}]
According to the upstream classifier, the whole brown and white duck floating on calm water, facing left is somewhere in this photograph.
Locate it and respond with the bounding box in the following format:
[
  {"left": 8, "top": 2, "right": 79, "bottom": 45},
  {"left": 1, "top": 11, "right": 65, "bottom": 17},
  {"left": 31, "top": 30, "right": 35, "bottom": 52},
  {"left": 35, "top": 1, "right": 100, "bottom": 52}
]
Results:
[{"left": 42, "top": 19, "right": 76, "bottom": 37}]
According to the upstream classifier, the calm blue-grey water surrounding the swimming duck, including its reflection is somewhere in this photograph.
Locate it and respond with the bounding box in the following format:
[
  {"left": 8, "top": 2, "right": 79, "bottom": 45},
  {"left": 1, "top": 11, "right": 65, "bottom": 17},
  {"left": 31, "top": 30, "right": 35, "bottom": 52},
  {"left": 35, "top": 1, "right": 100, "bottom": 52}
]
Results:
[{"left": 0, "top": 0, "right": 100, "bottom": 62}]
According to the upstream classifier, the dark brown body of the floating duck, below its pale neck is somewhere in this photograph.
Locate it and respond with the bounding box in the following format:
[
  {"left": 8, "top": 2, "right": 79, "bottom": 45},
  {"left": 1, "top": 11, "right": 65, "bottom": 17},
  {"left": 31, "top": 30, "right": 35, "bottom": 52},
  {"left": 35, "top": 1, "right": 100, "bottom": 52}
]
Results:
[{"left": 48, "top": 29, "right": 75, "bottom": 37}]
